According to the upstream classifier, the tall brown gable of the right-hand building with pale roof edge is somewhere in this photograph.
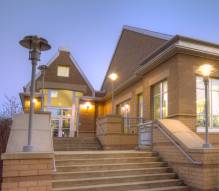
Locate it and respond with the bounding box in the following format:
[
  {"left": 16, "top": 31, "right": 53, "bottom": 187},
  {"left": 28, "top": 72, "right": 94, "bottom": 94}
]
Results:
[{"left": 101, "top": 26, "right": 172, "bottom": 91}]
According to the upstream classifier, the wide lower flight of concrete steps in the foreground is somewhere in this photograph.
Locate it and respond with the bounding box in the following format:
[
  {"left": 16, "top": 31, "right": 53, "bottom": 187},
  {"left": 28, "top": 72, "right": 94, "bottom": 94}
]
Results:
[{"left": 52, "top": 151, "right": 189, "bottom": 191}]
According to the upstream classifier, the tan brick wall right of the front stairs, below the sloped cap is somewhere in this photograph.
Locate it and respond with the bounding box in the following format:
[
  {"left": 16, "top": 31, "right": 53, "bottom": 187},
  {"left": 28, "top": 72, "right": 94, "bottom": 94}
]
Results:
[{"left": 153, "top": 128, "right": 219, "bottom": 191}]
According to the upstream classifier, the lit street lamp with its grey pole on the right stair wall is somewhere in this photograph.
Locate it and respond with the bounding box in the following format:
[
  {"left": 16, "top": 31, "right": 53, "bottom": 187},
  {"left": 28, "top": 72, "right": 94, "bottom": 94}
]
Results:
[{"left": 199, "top": 64, "right": 214, "bottom": 148}]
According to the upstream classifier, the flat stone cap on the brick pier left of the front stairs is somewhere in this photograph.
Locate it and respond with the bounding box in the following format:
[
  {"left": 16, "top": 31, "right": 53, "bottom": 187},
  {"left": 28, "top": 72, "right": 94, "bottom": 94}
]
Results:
[{"left": 1, "top": 152, "right": 54, "bottom": 160}]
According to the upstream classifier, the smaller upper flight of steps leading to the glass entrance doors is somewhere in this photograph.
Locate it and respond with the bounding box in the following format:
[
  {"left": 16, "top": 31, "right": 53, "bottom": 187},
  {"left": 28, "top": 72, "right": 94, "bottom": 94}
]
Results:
[{"left": 53, "top": 137, "right": 101, "bottom": 151}]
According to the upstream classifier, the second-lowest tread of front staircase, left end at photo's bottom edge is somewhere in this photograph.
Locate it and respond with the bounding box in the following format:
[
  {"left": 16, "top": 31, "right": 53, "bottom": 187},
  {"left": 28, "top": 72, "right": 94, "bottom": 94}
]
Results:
[{"left": 53, "top": 179, "right": 182, "bottom": 191}]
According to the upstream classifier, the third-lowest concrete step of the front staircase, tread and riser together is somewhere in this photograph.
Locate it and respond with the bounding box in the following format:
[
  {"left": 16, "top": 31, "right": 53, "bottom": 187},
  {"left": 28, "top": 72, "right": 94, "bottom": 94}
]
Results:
[{"left": 52, "top": 173, "right": 176, "bottom": 188}]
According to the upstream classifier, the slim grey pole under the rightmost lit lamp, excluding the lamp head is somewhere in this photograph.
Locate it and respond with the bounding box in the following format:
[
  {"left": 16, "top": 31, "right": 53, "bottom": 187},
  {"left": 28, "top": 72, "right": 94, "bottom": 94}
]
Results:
[{"left": 203, "top": 76, "right": 211, "bottom": 148}]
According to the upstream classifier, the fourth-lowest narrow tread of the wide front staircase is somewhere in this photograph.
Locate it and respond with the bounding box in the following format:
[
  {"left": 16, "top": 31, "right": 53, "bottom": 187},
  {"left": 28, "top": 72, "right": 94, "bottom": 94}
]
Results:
[{"left": 55, "top": 167, "right": 169, "bottom": 174}]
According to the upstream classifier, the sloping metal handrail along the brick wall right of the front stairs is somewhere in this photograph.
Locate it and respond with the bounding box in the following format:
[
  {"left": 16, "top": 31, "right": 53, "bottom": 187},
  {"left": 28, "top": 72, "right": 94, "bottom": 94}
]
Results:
[{"left": 139, "top": 121, "right": 202, "bottom": 165}]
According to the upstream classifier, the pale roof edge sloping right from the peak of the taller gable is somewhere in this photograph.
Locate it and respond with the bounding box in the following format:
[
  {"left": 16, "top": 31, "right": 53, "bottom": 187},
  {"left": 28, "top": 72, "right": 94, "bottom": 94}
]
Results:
[{"left": 123, "top": 25, "right": 173, "bottom": 40}]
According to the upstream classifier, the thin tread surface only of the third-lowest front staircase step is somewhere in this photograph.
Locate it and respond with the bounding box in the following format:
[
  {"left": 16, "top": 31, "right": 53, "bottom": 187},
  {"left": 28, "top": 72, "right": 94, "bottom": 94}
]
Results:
[{"left": 52, "top": 173, "right": 176, "bottom": 182}]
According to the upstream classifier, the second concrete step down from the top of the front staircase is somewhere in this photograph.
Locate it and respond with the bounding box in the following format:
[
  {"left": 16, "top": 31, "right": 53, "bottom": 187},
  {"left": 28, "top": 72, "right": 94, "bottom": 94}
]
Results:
[{"left": 56, "top": 157, "right": 160, "bottom": 166}]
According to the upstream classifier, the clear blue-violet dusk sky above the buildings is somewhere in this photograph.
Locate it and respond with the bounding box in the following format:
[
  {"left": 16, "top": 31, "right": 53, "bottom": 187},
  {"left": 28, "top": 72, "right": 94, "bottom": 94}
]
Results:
[{"left": 0, "top": 0, "right": 219, "bottom": 104}]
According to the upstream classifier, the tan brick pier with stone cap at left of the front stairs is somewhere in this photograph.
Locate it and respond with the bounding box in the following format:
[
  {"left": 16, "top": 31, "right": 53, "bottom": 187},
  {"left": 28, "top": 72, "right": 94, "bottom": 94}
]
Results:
[{"left": 2, "top": 153, "right": 53, "bottom": 191}]
